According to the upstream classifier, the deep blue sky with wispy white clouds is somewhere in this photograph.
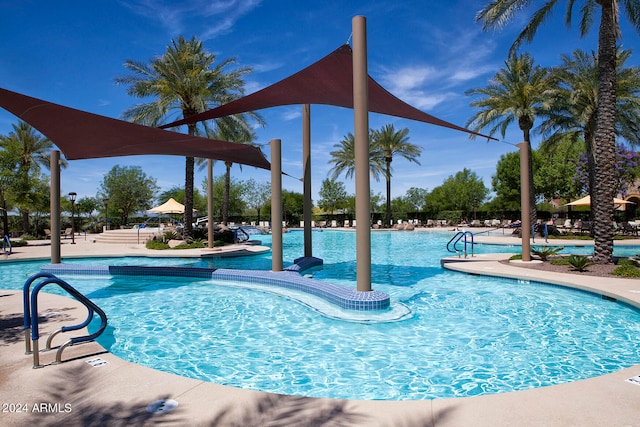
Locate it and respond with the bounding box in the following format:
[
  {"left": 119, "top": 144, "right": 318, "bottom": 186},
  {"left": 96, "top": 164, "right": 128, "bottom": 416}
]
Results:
[{"left": 0, "top": 0, "right": 640, "bottom": 201}]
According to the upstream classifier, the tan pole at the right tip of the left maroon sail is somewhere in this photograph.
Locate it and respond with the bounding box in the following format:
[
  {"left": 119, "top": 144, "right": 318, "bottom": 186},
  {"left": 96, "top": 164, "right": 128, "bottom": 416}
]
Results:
[{"left": 269, "top": 139, "right": 282, "bottom": 271}]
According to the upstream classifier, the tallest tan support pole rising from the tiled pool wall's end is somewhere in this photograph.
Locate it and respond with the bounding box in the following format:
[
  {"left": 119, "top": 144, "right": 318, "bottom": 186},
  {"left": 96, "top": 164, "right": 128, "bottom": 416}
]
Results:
[{"left": 351, "top": 16, "right": 371, "bottom": 292}]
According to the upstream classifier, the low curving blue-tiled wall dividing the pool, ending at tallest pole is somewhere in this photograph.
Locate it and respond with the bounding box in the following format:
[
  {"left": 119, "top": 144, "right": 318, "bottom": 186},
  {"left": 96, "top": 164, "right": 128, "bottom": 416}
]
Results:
[{"left": 41, "top": 264, "right": 391, "bottom": 311}]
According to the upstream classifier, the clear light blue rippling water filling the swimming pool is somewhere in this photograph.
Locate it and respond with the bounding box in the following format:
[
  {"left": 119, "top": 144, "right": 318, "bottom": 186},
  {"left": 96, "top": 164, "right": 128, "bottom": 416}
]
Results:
[{"left": 5, "top": 231, "right": 640, "bottom": 400}]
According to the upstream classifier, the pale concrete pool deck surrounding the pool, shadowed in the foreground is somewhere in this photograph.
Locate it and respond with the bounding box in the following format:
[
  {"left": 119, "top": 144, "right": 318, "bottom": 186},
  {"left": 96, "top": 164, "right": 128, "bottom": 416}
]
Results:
[{"left": 0, "top": 236, "right": 640, "bottom": 427}]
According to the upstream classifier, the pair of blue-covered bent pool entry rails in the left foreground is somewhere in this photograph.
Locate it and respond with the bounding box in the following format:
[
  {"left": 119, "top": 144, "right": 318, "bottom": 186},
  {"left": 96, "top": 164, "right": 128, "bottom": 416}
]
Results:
[{"left": 25, "top": 273, "right": 107, "bottom": 368}]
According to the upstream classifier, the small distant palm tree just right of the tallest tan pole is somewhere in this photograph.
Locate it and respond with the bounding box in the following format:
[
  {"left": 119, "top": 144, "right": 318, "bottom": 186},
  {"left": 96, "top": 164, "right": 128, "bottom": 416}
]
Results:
[{"left": 373, "top": 124, "right": 422, "bottom": 227}]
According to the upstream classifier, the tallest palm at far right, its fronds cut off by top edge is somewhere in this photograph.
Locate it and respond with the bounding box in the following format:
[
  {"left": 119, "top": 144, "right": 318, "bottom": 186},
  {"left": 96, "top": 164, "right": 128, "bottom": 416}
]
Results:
[{"left": 476, "top": 0, "right": 640, "bottom": 264}]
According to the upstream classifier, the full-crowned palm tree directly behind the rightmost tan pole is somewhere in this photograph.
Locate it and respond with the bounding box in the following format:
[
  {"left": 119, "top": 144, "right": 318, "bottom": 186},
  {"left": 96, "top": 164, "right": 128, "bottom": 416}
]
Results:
[{"left": 466, "top": 53, "right": 552, "bottom": 224}]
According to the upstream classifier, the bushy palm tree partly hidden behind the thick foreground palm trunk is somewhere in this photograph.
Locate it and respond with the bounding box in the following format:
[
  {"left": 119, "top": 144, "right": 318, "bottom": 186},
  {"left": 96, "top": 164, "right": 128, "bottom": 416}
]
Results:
[{"left": 540, "top": 49, "right": 640, "bottom": 205}]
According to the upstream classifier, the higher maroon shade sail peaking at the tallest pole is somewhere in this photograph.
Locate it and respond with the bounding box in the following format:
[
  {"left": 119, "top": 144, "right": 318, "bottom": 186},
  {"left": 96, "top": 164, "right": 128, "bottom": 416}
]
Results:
[{"left": 161, "top": 44, "right": 495, "bottom": 139}]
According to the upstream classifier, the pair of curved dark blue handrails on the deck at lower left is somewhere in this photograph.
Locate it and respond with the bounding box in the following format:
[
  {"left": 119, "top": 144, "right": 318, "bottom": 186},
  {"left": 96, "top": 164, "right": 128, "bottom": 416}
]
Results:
[{"left": 23, "top": 273, "right": 107, "bottom": 369}]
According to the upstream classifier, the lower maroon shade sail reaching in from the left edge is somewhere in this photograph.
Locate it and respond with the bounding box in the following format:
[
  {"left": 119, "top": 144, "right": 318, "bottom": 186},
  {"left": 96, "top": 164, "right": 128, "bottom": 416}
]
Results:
[{"left": 0, "top": 88, "right": 270, "bottom": 170}]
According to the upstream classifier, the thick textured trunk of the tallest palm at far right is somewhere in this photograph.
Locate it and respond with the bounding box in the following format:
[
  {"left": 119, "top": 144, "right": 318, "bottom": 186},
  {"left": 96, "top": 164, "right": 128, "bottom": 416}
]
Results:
[{"left": 591, "top": 1, "right": 616, "bottom": 264}]
